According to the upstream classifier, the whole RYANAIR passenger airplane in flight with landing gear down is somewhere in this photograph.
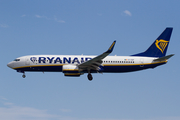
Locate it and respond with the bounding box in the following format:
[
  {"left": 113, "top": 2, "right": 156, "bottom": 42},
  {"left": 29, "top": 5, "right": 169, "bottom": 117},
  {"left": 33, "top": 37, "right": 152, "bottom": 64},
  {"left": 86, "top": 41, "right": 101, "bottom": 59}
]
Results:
[{"left": 7, "top": 27, "right": 174, "bottom": 81}]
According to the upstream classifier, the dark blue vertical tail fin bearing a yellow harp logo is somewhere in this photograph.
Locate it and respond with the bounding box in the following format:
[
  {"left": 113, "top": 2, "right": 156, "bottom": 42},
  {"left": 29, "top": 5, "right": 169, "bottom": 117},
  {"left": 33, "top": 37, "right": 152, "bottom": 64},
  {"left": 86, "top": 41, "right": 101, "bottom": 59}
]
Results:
[{"left": 132, "top": 28, "right": 173, "bottom": 57}]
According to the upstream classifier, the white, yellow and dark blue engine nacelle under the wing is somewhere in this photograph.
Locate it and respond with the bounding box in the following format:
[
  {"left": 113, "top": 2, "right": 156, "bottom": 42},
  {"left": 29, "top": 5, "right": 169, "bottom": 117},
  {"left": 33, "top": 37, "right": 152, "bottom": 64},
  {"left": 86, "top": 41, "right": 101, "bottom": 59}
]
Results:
[{"left": 62, "top": 65, "right": 81, "bottom": 77}]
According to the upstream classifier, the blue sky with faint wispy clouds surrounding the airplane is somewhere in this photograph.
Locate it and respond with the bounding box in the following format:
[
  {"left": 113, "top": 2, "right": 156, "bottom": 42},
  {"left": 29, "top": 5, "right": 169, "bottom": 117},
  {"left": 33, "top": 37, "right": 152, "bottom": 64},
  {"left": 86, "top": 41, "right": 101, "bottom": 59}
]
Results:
[{"left": 0, "top": 0, "right": 180, "bottom": 120}]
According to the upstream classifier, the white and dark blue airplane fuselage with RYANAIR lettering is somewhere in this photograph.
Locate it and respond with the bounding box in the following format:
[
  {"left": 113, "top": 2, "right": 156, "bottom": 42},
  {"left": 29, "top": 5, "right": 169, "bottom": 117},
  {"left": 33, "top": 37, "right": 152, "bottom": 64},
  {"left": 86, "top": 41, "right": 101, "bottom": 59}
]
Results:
[{"left": 8, "top": 55, "right": 167, "bottom": 72}]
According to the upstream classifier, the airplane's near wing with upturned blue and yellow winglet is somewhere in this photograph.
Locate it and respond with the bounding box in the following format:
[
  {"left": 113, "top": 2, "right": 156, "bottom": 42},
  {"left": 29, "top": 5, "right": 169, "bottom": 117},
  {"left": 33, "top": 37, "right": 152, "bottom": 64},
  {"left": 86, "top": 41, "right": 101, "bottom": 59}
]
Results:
[{"left": 78, "top": 41, "right": 116, "bottom": 71}]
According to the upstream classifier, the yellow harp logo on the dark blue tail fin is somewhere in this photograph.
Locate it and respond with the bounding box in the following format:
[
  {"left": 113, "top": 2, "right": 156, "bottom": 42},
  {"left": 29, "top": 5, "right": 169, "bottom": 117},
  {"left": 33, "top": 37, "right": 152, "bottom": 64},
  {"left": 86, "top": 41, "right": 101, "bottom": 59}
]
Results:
[{"left": 155, "top": 39, "right": 169, "bottom": 53}]
